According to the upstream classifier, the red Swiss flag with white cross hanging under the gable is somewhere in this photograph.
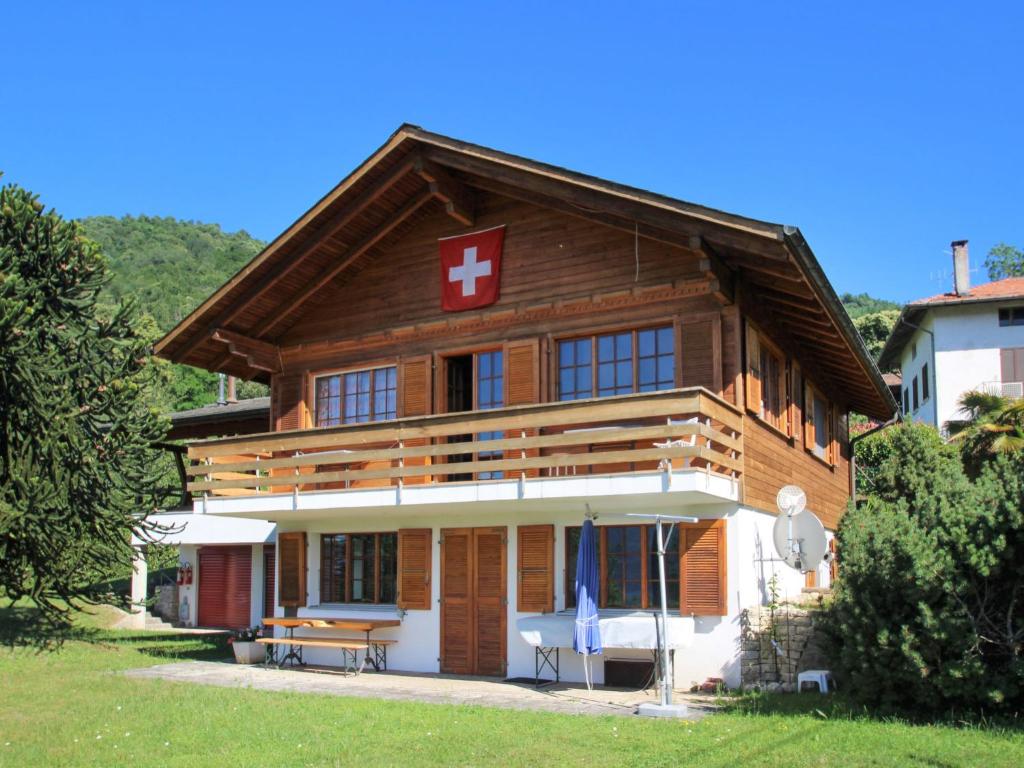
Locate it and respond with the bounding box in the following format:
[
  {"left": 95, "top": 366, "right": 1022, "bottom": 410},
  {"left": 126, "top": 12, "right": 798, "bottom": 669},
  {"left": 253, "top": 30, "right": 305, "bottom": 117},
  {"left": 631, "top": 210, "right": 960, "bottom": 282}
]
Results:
[{"left": 437, "top": 225, "right": 505, "bottom": 312}]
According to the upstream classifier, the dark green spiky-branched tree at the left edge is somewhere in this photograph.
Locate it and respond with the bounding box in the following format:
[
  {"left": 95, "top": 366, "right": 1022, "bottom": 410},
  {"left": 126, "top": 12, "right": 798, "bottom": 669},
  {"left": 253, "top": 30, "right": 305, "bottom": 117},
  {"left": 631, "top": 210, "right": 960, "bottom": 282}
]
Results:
[{"left": 0, "top": 185, "right": 172, "bottom": 627}]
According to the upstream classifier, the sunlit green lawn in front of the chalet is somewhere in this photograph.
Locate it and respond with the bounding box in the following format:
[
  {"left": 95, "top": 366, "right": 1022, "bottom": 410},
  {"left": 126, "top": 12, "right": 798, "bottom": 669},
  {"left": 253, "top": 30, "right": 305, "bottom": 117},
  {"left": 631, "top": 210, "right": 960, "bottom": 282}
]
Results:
[{"left": 0, "top": 606, "right": 1024, "bottom": 768}]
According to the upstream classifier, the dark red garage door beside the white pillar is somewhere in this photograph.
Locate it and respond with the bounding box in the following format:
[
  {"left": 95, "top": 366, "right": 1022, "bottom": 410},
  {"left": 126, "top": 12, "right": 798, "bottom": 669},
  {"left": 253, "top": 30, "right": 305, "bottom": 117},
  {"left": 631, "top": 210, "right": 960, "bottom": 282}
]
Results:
[{"left": 198, "top": 547, "right": 252, "bottom": 628}]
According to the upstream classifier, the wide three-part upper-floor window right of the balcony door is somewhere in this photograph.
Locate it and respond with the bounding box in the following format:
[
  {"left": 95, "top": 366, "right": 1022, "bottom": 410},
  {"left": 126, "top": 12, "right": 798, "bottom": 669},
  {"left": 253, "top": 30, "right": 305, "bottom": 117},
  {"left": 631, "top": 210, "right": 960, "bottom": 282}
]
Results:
[{"left": 558, "top": 326, "right": 676, "bottom": 400}]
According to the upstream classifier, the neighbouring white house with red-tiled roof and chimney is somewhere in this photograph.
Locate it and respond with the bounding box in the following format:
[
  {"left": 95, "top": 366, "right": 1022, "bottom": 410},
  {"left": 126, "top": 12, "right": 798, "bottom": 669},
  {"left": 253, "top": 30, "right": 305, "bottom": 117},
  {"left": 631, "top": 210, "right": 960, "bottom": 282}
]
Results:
[{"left": 880, "top": 241, "right": 1024, "bottom": 429}]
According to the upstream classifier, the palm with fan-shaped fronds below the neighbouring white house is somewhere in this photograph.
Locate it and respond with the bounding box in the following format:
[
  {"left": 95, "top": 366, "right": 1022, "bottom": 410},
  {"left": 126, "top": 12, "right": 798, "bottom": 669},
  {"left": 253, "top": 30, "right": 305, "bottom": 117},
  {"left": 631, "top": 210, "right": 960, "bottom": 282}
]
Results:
[{"left": 945, "top": 390, "right": 1024, "bottom": 462}]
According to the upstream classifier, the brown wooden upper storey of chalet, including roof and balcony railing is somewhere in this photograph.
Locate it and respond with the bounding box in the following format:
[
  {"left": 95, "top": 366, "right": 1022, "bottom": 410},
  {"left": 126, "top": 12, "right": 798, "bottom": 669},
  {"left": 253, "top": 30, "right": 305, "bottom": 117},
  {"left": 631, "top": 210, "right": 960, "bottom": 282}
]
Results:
[{"left": 158, "top": 128, "right": 893, "bottom": 528}]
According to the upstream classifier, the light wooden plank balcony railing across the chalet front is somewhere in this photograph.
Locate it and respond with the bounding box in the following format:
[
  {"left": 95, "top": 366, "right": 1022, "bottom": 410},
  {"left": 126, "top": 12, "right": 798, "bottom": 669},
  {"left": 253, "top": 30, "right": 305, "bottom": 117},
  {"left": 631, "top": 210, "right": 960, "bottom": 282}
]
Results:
[{"left": 186, "top": 388, "right": 743, "bottom": 496}]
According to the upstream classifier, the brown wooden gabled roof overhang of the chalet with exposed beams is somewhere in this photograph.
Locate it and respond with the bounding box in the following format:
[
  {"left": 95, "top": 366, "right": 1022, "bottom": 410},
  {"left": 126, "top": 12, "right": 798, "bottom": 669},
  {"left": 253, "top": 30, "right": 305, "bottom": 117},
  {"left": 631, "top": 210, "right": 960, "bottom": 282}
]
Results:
[{"left": 156, "top": 125, "right": 897, "bottom": 418}]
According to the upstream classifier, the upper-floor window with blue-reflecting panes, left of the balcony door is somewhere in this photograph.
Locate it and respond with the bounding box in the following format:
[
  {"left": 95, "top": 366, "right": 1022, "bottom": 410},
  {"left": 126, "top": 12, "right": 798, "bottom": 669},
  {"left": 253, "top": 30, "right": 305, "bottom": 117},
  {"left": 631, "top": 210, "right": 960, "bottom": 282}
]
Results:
[{"left": 313, "top": 366, "right": 398, "bottom": 427}]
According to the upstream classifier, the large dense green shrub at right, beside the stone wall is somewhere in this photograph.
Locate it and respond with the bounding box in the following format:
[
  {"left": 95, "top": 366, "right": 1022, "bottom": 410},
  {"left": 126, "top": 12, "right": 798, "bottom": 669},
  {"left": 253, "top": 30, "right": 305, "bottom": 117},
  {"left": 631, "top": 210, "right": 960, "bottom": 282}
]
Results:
[{"left": 824, "top": 427, "right": 1024, "bottom": 714}]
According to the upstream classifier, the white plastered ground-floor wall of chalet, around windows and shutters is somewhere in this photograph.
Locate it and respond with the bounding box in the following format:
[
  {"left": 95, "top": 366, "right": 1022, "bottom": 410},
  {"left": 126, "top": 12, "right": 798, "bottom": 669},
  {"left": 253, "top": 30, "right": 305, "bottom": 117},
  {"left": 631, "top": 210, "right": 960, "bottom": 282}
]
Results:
[{"left": 222, "top": 502, "right": 828, "bottom": 689}]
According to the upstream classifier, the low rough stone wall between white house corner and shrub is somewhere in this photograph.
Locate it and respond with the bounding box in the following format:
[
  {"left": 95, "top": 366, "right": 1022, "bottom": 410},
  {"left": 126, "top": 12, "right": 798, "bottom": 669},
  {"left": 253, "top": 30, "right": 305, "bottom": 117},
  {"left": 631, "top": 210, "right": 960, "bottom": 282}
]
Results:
[{"left": 740, "top": 595, "right": 828, "bottom": 691}]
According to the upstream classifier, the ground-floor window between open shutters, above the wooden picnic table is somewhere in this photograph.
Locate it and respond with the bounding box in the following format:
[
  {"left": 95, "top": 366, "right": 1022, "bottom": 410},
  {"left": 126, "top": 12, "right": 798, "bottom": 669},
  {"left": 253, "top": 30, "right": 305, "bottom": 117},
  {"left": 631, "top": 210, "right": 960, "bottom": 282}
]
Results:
[{"left": 321, "top": 532, "right": 398, "bottom": 604}]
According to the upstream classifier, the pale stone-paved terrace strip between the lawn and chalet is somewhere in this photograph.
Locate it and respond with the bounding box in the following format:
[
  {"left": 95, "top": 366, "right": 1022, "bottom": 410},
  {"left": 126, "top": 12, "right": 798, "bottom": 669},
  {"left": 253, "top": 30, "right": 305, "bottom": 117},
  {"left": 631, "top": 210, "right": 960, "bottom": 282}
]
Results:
[{"left": 124, "top": 662, "right": 715, "bottom": 720}]
